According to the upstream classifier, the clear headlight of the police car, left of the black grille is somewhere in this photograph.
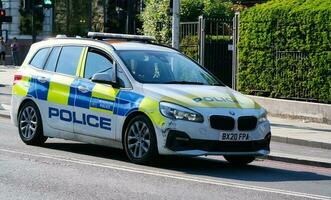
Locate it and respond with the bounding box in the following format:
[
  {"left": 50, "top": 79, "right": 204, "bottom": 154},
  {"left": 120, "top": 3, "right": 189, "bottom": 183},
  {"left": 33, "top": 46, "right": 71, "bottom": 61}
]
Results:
[{"left": 160, "top": 102, "right": 203, "bottom": 122}]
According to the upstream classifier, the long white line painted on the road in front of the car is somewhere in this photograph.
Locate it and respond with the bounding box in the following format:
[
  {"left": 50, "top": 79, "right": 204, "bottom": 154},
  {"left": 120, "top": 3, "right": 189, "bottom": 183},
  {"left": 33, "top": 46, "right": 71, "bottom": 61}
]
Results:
[{"left": 0, "top": 149, "right": 331, "bottom": 200}]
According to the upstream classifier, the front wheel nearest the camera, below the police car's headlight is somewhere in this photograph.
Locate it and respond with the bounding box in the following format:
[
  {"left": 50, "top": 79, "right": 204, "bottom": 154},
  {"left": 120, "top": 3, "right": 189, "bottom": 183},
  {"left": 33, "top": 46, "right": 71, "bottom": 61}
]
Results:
[{"left": 123, "top": 115, "right": 158, "bottom": 164}]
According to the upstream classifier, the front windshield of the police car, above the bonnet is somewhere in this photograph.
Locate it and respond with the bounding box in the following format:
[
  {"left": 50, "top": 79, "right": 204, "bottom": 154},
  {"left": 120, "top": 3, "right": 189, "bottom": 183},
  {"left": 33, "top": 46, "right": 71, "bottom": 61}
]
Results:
[{"left": 117, "top": 50, "right": 223, "bottom": 85}]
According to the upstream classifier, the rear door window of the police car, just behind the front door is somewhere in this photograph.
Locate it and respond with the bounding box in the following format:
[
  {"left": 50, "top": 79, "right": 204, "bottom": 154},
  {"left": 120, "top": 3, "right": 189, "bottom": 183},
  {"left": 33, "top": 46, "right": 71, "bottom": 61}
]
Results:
[{"left": 56, "top": 46, "right": 83, "bottom": 76}]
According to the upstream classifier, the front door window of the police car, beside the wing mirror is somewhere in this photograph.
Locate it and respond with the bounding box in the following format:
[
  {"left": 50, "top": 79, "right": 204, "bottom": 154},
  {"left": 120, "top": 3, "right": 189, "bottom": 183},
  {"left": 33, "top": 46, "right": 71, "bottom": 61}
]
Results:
[{"left": 84, "top": 49, "right": 113, "bottom": 79}]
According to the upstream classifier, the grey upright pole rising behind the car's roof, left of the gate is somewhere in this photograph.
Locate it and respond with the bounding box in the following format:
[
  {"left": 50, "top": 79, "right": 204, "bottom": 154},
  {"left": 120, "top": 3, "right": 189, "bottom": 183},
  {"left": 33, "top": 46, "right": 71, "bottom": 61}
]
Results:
[{"left": 172, "top": 0, "right": 180, "bottom": 49}]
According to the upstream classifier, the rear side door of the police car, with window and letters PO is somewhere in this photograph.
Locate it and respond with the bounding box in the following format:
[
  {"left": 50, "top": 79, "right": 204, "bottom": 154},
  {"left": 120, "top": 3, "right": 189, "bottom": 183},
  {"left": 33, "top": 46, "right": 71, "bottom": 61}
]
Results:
[{"left": 42, "top": 46, "right": 85, "bottom": 132}]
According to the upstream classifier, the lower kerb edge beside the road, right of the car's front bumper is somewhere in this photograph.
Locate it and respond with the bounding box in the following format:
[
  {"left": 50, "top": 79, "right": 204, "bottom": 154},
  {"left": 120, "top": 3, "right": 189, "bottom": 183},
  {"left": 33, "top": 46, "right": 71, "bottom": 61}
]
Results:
[{"left": 265, "top": 154, "right": 331, "bottom": 168}]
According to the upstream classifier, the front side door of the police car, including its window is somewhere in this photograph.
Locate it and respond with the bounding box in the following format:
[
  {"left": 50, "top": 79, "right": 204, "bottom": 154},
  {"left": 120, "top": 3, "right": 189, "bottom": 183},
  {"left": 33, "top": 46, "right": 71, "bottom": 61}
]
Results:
[{"left": 73, "top": 48, "right": 119, "bottom": 139}]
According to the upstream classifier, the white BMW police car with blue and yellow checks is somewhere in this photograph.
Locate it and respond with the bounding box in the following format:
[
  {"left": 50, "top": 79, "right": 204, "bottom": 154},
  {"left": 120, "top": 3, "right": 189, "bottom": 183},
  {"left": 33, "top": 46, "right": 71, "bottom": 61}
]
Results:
[{"left": 11, "top": 32, "right": 271, "bottom": 164}]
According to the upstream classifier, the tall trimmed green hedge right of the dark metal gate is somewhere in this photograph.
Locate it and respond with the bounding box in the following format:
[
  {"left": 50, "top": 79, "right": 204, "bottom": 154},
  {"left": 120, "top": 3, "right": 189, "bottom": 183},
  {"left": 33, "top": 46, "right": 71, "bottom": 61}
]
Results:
[{"left": 238, "top": 0, "right": 331, "bottom": 103}]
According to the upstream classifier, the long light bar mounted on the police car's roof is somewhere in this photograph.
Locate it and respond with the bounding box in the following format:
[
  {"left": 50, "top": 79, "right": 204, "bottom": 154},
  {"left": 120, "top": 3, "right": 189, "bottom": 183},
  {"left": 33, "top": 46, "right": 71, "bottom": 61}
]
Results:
[{"left": 87, "top": 32, "right": 155, "bottom": 42}]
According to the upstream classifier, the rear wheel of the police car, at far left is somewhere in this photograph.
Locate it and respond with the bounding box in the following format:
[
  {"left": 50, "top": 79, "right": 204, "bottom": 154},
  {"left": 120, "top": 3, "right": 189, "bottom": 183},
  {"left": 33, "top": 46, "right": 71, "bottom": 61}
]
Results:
[{"left": 18, "top": 101, "right": 47, "bottom": 145}]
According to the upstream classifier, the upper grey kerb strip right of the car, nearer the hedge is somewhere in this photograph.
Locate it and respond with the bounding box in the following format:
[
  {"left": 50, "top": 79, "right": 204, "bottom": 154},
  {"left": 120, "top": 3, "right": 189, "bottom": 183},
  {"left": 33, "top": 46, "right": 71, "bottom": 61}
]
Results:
[{"left": 271, "top": 135, "right": 331, "bottom": 149}]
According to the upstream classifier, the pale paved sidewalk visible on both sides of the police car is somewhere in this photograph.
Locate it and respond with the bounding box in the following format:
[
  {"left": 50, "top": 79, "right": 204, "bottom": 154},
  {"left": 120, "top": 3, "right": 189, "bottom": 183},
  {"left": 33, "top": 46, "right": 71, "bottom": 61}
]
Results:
[{"left": 0, "top": 66, "right": 331, "bottom": 168}]
